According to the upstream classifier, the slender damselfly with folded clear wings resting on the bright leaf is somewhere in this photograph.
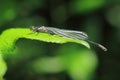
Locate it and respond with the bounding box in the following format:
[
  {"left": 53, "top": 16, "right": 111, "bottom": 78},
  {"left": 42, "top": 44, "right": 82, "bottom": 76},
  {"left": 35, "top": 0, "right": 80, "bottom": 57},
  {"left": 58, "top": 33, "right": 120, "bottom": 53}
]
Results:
[{"left": 30, "top": 26, "right": 107, "bottom": 51}]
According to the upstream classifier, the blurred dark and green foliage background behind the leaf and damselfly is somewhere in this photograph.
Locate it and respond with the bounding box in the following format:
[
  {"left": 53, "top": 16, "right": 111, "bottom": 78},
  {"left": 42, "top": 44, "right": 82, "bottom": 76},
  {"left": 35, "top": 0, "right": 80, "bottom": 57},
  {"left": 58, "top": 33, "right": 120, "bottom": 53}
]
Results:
[{"left": 0, "top": 0, "right": 120, "bottom": 80}]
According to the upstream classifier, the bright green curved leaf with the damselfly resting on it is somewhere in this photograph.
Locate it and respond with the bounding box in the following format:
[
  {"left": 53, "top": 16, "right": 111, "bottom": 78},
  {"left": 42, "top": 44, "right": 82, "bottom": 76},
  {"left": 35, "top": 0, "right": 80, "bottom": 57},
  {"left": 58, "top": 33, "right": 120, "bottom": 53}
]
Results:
[{"left": 0, "top": 28, "right": 90, "bottom": 53}]
